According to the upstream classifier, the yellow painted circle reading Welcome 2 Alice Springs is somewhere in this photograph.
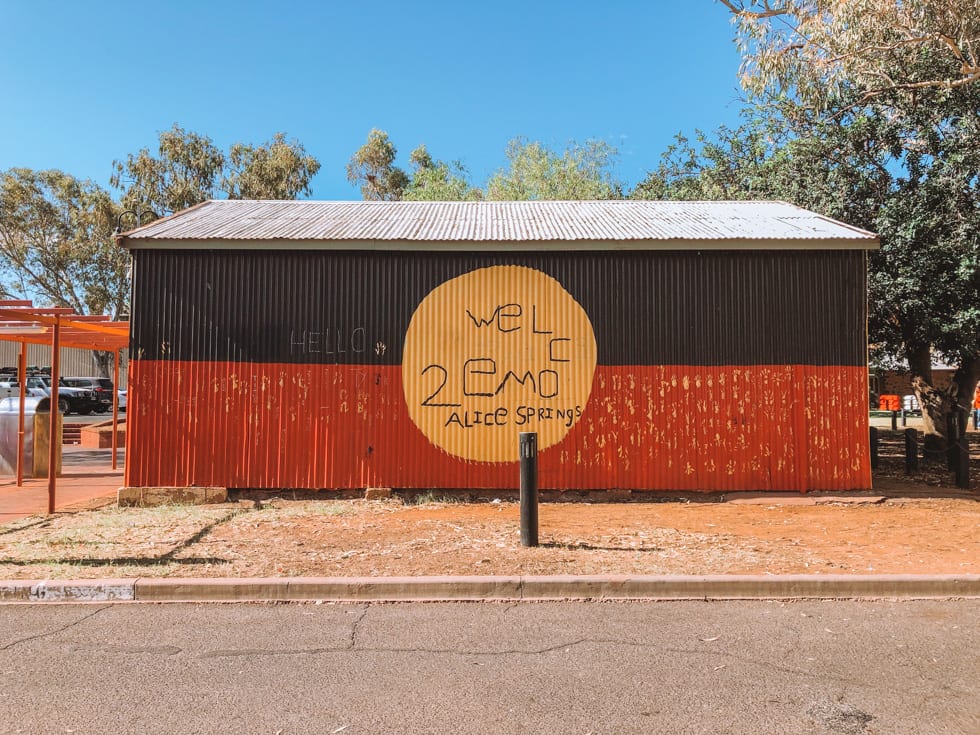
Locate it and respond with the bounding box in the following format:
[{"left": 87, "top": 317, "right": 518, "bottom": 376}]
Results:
[{"left": 402, "top": 265, "right": 596, "bottom": 462}]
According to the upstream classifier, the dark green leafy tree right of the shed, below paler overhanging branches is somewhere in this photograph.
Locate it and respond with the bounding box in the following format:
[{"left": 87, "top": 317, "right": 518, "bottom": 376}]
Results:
[{"left": 632, "top": 85, "right": 980, "bottom": 447}]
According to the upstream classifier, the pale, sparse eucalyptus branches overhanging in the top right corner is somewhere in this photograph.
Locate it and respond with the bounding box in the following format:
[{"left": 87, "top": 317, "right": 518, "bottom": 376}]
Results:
[{"left": 719, "top": 0, "right": 980, "bottom": 108}]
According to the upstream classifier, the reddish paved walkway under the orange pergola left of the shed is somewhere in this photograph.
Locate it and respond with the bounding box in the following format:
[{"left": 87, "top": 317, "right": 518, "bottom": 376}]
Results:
[{"left": 0, "top": 447, "right": 125, "bottom": 523}]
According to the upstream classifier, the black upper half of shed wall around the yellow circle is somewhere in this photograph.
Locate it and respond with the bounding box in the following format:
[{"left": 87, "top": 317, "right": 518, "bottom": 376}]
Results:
[{"left": 131, "top": 250, "right": 867, "bottom": 365}]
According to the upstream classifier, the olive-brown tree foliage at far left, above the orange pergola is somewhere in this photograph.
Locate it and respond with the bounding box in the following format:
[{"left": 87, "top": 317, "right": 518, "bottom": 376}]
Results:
[{"left": 0, "top": 168, "right": 129, "bottom": 317}]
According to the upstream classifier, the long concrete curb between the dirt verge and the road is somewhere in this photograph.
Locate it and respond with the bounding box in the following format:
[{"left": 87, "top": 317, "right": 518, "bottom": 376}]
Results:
[{"left": 0, "top": 575, "right": 980, "bottom": 603}]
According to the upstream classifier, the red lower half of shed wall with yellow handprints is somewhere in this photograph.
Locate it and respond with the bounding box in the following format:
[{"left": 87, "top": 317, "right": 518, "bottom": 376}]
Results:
[{"left": 126, "top": 360, "right": 871, "bottom": 492}]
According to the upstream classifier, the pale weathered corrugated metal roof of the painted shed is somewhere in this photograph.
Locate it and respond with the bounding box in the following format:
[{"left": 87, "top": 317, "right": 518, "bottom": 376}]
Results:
[{"left": 121, "top": 200, "right": 878, "bottom": 249}]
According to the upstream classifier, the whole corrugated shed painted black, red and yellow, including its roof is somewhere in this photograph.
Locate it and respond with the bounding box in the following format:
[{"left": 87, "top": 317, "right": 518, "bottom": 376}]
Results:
[{"left": 120, "top": 201, "right": 878, "bottom": 491}]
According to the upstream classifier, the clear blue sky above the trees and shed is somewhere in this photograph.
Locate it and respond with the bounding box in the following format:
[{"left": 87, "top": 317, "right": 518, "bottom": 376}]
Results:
[{"left": 0, "top": 0, "right": 741, "bottom": 199}]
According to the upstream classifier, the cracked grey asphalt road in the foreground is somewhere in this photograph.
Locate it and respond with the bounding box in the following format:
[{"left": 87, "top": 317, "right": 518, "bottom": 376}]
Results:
[{"left": 0, "top": 600, "right": 980, "bottom": 735}]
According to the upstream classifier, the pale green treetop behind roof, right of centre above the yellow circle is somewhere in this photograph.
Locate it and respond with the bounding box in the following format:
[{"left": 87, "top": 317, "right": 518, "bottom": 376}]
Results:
[{"left": 486, "top": 138, "right": 623, "bottom": 200}]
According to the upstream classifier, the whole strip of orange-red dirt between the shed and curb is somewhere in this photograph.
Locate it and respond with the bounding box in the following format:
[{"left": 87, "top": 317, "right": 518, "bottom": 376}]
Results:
[{"left": 0, "top": 436, "right": 980, "bottom": 579}]
